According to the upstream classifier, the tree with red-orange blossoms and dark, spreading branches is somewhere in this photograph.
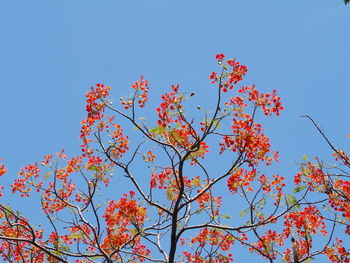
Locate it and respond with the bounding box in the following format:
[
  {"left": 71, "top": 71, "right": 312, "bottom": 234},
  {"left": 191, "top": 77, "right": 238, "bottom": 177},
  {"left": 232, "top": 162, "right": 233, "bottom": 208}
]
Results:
[{"left": 0, "top": 54, "right": 350, "bottom": 262}]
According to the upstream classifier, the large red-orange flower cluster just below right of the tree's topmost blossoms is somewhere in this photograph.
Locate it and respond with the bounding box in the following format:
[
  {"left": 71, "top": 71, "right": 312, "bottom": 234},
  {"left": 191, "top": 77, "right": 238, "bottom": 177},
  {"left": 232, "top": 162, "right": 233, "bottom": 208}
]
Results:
[{"left": 217, "top": 68, "right": 283, "bottom": 165}]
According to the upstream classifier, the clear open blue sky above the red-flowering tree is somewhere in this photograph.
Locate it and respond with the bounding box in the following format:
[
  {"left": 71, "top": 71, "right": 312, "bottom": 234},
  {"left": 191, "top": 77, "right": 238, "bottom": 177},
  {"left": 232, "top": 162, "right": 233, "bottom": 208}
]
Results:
[{"left": 0, "top": 0, "right": 350, "bottom": 262}]
